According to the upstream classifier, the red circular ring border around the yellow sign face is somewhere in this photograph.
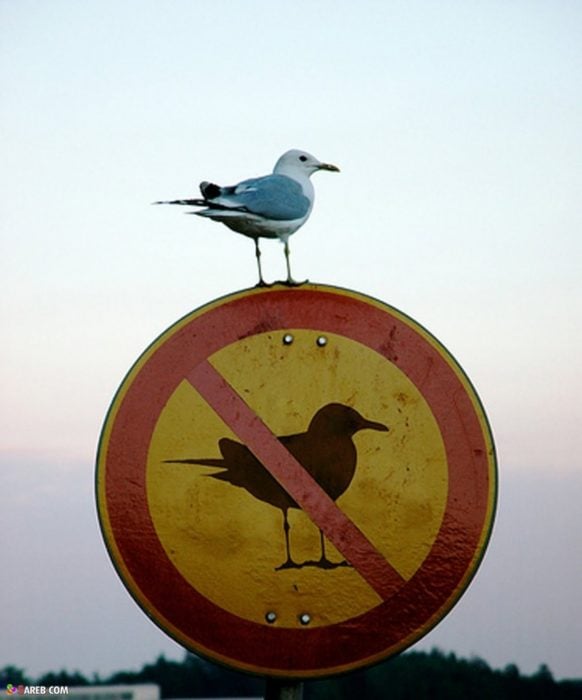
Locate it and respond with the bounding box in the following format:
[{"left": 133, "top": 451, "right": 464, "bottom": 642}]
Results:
[{"left": 98, "top": 288, "right": 491, "bottom": 677}]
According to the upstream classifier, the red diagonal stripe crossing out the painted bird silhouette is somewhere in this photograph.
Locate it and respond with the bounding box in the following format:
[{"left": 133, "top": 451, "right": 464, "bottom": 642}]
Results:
[{"left": 186, "top": 360, "right": 406, "bottom": 600}]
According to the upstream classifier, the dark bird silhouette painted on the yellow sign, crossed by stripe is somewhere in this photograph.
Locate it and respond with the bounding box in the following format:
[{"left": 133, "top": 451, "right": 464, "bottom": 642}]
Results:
[{"left": 164, "top": 403, "right": 388, "bottom": 570}]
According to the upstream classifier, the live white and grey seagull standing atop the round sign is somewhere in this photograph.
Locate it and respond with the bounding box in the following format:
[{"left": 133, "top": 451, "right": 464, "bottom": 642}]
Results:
[{"left": 154, "top": 149, "right": 339, "bottom": 287}]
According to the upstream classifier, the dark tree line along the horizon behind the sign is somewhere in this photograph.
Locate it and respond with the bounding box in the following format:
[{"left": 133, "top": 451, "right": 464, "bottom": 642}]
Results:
[{"left": 0, "top": 649, "right": 582, "bottom": 700}]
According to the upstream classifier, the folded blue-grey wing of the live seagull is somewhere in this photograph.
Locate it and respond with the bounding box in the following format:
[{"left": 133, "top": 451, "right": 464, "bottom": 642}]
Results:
[{"left": 205, "top": 175, "right": 311, "bottom": 221}]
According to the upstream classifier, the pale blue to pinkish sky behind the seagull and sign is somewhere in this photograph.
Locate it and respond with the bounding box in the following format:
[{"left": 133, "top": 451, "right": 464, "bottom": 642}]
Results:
[{"left": 0, "top": 0, "right": 582, "bottom": 677}]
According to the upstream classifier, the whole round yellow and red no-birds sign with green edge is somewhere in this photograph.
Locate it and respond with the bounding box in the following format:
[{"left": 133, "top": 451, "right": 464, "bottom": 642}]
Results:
[{"left": 97, "top": 285, "right": 496, "bottom": 678}]
